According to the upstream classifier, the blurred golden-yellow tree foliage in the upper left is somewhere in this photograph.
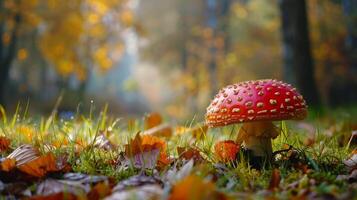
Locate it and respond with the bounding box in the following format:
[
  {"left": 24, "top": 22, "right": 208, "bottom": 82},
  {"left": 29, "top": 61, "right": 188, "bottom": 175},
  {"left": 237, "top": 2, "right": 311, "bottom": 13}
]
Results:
[{"left": 0, "top": 0, "right": 135, "bottom": 104}]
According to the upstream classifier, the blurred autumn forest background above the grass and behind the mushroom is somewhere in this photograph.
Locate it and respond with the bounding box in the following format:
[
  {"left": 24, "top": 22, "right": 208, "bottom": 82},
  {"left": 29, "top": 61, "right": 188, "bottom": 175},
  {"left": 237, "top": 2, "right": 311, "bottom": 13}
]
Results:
[{"left": 0, "top": 0, "right": 357, "bottom": 119}]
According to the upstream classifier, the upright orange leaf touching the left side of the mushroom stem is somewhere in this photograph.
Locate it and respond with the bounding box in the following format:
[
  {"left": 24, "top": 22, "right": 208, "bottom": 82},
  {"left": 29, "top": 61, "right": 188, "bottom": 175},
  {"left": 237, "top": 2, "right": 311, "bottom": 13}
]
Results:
[{"left": 214, "top": 140, "right": 240, "bottom": 162}]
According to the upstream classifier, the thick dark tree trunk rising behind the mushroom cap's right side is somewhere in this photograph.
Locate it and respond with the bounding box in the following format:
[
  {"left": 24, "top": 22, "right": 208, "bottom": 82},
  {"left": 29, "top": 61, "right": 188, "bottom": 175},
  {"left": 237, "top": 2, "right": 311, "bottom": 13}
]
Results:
[{"left": 279, "top": 0, "right": 320, "bottom": 106}]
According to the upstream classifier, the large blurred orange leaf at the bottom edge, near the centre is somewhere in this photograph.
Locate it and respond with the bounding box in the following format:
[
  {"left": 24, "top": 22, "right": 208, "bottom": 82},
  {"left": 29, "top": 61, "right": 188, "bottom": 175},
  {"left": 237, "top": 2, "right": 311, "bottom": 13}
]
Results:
[{"left": 169, "top": 175, "right": 226, "bottom": 200}]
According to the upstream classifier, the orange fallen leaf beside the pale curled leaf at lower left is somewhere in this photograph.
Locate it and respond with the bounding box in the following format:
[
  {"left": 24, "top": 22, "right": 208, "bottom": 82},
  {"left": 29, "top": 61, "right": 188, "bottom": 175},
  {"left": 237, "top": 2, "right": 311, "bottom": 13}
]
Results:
[{"left": 18, "top": 153, "right": 58, "bottom": 178}]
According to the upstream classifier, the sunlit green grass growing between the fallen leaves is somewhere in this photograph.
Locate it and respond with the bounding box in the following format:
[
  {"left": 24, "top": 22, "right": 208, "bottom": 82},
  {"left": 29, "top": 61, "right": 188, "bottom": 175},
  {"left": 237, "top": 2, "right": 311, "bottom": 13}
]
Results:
[{"left": 0, "top": 105, "right": 357, "bottom": 199}]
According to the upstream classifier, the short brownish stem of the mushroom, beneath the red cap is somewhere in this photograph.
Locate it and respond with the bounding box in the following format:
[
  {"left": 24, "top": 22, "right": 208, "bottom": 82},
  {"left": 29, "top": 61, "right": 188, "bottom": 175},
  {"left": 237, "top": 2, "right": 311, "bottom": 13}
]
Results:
[{"left": 237, "top": 121, "right": 279, "bottom": 158}]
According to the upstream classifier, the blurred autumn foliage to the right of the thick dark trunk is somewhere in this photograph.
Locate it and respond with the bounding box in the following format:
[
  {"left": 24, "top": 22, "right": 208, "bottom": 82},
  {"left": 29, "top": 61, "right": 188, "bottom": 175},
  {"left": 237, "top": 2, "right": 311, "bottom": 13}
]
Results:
[{"left": 308, "top": 0, "right": 357, "bottom": 106}]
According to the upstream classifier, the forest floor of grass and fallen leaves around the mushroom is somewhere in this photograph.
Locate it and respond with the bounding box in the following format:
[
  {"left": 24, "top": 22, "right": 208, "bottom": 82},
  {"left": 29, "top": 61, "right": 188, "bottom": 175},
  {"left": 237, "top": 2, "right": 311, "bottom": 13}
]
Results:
[{"left": 0, "top": 105, "right": 357, "bottom": 200}]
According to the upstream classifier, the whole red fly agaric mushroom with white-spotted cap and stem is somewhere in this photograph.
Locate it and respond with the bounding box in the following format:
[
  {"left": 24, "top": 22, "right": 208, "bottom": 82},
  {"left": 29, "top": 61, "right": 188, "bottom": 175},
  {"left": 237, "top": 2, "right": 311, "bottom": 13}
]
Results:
[{"left": 206, "top": 79, "right": 307, "bottom": 158}]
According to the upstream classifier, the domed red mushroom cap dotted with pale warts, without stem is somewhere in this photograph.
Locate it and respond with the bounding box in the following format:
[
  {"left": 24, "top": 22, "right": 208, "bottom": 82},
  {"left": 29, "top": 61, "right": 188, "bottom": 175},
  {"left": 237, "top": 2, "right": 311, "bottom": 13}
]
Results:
[{"left": 206, "top": 79, "right": 307, "bottom": 127}]
